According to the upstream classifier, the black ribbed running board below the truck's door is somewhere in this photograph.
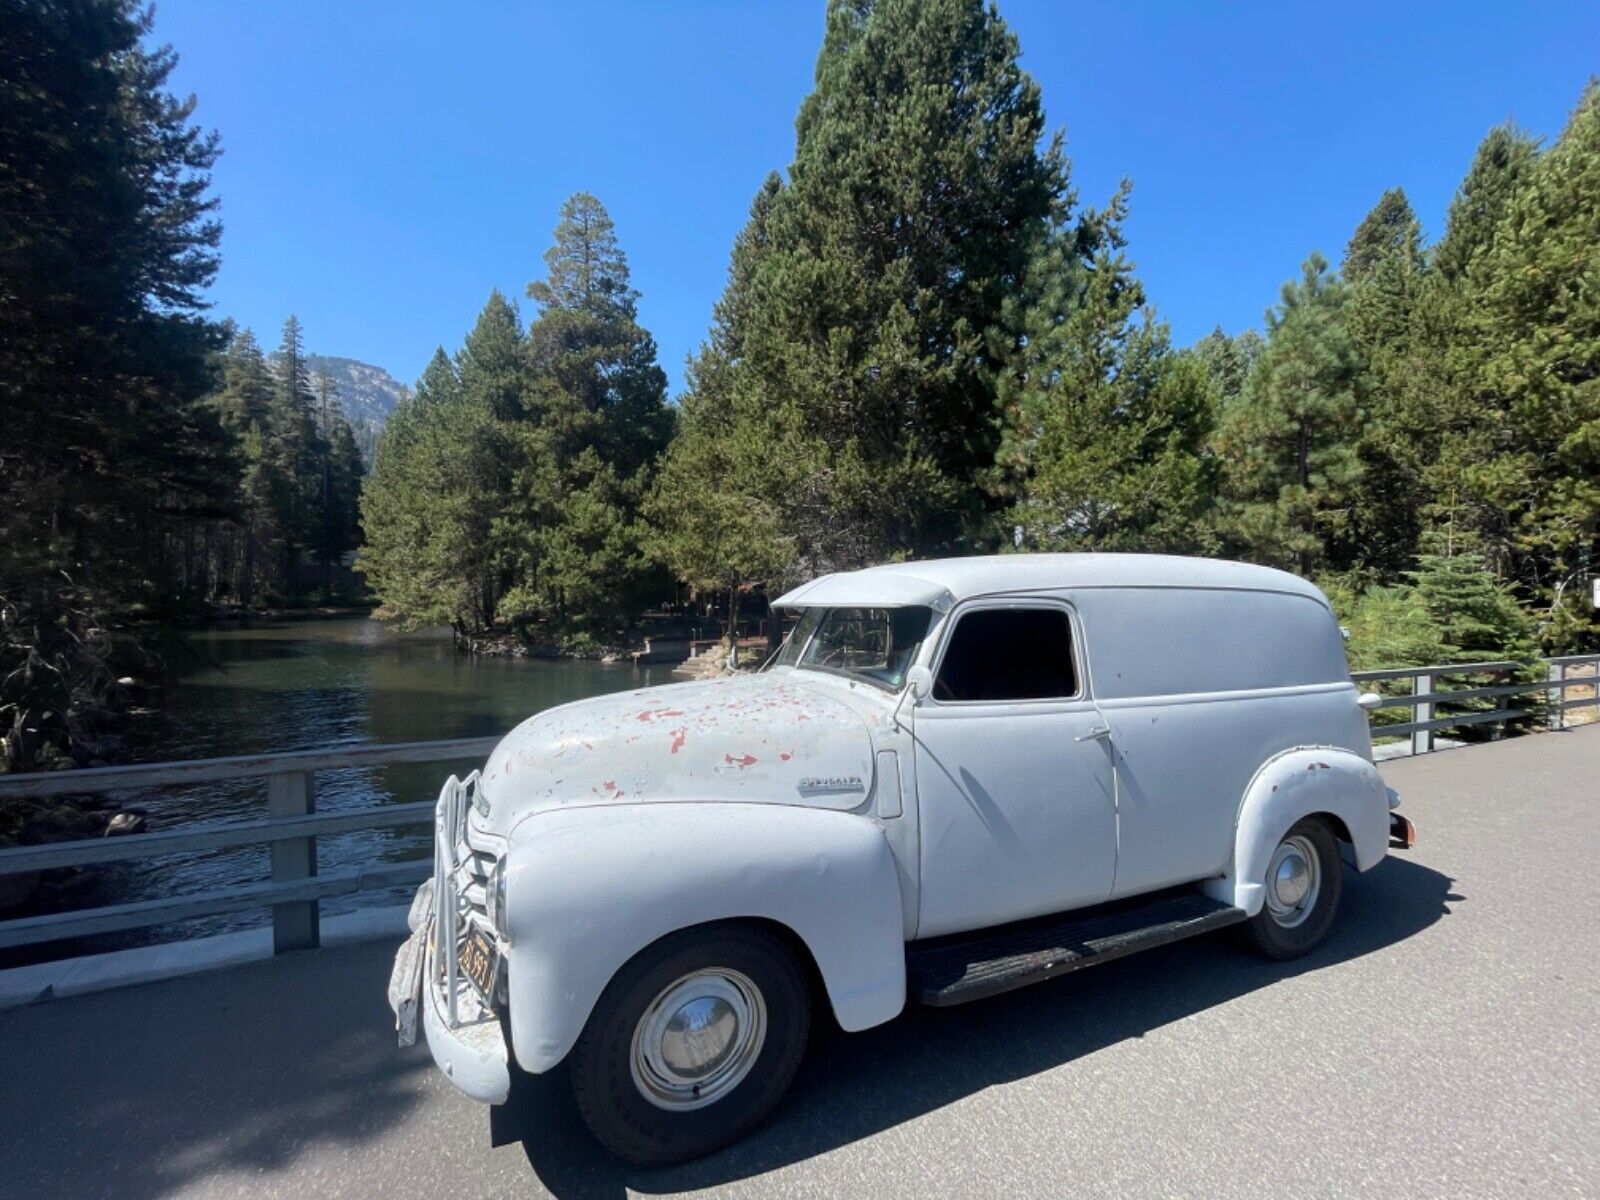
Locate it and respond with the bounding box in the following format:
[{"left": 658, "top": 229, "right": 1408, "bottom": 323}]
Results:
[{"left": 906, "top": 888, "right": 1246, "bottom": 1008}]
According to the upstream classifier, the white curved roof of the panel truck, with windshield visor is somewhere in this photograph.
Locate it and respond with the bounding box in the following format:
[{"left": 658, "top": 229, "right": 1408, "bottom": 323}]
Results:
[{"left": 773, "top": 554, "right": 1328, "bottom": 611}]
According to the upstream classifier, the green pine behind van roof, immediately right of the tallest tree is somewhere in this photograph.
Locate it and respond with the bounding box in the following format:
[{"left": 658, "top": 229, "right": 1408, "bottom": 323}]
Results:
[{"left": 995, "top": 184, "right": 1213, "bottom": 554}]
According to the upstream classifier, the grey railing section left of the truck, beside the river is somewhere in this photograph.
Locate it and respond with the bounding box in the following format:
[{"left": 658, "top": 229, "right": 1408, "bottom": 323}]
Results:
[{"left": 0, "top": 738, "right": 499, "bottom": 952}]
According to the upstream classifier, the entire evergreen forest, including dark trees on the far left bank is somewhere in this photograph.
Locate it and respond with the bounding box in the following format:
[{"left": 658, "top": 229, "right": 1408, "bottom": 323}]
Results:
[{"left": 0, "top": 0, "right": 1600, "bottom": 768}]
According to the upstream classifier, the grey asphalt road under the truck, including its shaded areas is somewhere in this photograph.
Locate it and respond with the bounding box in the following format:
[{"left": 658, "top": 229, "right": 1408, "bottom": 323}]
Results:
[{"left": 0, "top": 726, "right": 1600, "bottom": 1200}]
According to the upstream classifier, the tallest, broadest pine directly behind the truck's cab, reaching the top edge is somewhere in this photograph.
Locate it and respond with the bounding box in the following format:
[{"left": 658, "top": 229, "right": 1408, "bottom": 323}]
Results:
[{"left": 744, "top": 0, "right": 1069, "bottom": 573}]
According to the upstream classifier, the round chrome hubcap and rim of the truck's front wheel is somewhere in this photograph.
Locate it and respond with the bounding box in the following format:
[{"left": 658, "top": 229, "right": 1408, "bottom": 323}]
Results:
[{"left": 629, "top": 968, "right": 766, "bottom": 1112}]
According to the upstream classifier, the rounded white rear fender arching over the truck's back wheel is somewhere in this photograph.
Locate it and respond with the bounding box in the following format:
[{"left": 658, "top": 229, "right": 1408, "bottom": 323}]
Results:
[{"left": 1203, "top": 747, "right": 1389, "bottom": 917}]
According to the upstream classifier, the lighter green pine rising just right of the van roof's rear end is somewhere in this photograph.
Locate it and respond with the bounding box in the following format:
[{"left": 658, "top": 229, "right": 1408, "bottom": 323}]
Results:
[{"left": 1216, "top": 254, "right": 1368, "bottom": 574}]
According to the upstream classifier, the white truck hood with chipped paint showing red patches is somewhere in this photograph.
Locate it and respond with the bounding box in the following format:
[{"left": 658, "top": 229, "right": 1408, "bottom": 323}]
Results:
[{"left": 474, "top": 672, "right": 886, "bottom": 837}]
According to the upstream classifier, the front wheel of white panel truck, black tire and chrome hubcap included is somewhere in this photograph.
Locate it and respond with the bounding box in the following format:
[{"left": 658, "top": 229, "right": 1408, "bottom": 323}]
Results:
[{"left": 570, "top": 926, "right": 811, "bottom": 1166}]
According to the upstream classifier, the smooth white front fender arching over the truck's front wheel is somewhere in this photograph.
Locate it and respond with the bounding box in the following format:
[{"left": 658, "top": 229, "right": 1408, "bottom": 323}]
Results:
[{"left": 506, "top": 803, "right": 906, "bottom": 1072}]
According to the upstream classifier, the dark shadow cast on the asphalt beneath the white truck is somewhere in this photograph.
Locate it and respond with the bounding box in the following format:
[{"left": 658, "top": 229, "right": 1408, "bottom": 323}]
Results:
[{"left": 518, "top": 858, "right": 1464, "bottom": 1198}]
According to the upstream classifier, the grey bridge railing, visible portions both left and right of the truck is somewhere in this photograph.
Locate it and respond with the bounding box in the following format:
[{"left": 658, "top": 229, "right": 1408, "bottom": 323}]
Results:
[{"left": 0, "top": 654, "right": 1600, "bottom": 952}]
